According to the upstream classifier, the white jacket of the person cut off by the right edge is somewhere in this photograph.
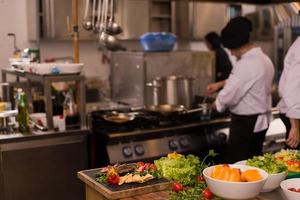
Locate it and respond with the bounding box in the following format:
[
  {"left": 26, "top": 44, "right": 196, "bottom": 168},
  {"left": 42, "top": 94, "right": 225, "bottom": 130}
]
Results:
[{"left": 278, "top": 37, "right": 300, "bottom": 119}]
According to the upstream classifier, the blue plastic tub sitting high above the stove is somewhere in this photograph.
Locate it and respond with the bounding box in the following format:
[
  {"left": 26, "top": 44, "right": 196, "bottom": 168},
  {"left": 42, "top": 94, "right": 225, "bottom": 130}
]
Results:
[{"left": 140, "top": 32, "right": 176, "bottom": 52}]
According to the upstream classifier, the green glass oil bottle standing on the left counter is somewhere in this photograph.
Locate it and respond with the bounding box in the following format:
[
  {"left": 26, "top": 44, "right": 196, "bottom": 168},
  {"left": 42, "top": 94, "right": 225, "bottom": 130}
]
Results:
[{"left": 17, "top": 92, "right": 29, "bottom": 134}]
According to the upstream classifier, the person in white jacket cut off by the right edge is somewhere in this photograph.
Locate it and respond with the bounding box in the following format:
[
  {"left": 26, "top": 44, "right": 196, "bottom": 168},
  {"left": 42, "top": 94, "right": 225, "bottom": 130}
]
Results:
[{"left": 278, "top": 37, "right": 300, "bottom": 149}]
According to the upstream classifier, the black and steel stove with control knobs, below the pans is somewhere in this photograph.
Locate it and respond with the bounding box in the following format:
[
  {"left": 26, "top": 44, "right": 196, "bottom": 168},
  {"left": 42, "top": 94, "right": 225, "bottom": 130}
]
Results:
[{"left": 90, "top": 110, "right": 229, "bottom": 167}]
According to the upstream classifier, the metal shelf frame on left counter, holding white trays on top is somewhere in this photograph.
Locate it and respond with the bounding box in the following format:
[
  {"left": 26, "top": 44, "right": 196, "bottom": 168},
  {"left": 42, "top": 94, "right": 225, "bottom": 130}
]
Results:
[{"left": 2, "top": 68, "right": 86, "bottom": 130}]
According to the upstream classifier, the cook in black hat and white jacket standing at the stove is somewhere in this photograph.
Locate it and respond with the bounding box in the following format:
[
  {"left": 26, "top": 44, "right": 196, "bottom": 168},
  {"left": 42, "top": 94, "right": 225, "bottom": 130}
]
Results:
[{"left": 207, "top": 17, "right": 274, "bottom": 163}]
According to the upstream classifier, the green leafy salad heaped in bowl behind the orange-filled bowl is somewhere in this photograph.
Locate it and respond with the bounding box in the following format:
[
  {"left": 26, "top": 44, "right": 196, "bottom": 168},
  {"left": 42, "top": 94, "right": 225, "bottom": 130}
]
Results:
[{"left": 247, "top": 153, "right": 287, "bottom": 174}]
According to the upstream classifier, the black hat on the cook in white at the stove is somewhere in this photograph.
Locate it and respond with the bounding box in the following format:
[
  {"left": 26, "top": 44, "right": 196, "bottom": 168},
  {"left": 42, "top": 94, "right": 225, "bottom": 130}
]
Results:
[{"left": 221, "top": 17, "right": 252, "bottom": 49}]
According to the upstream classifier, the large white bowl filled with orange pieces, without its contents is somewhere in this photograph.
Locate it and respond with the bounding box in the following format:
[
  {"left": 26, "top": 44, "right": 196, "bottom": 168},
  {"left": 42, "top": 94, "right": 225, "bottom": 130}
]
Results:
[{"left": 203, "top": 165, "right": 268, "bottom": 199}]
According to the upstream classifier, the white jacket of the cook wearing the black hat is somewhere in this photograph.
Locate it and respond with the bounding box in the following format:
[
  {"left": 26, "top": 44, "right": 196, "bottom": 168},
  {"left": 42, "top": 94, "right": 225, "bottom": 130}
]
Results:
[{"left": 216, "top": 47, "right": 274, "bottom": 132}]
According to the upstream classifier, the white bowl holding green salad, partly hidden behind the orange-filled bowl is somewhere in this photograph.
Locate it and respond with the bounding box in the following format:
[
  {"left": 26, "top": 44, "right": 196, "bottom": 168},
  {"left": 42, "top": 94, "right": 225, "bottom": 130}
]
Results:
[{"left": 235, "top": 160, "right": 287, "bottom": 192}]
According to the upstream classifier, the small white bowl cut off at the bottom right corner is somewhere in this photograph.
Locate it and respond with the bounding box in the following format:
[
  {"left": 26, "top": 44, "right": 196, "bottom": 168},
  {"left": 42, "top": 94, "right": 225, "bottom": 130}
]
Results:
[{"left": 280, "top": 178, "right": 300, "bottom": 200}]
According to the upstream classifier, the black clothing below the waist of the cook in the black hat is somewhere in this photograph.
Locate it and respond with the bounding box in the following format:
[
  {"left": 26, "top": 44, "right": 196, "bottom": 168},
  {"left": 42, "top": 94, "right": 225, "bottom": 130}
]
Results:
[{"left": 225, "top": 114, "right": 267, "bottom": 163}]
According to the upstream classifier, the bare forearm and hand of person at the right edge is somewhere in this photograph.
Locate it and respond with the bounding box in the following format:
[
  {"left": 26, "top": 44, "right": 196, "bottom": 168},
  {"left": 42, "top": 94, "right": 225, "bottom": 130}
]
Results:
[{"left": 286, "top": 118, "right": 300, "bottom": 148}]
